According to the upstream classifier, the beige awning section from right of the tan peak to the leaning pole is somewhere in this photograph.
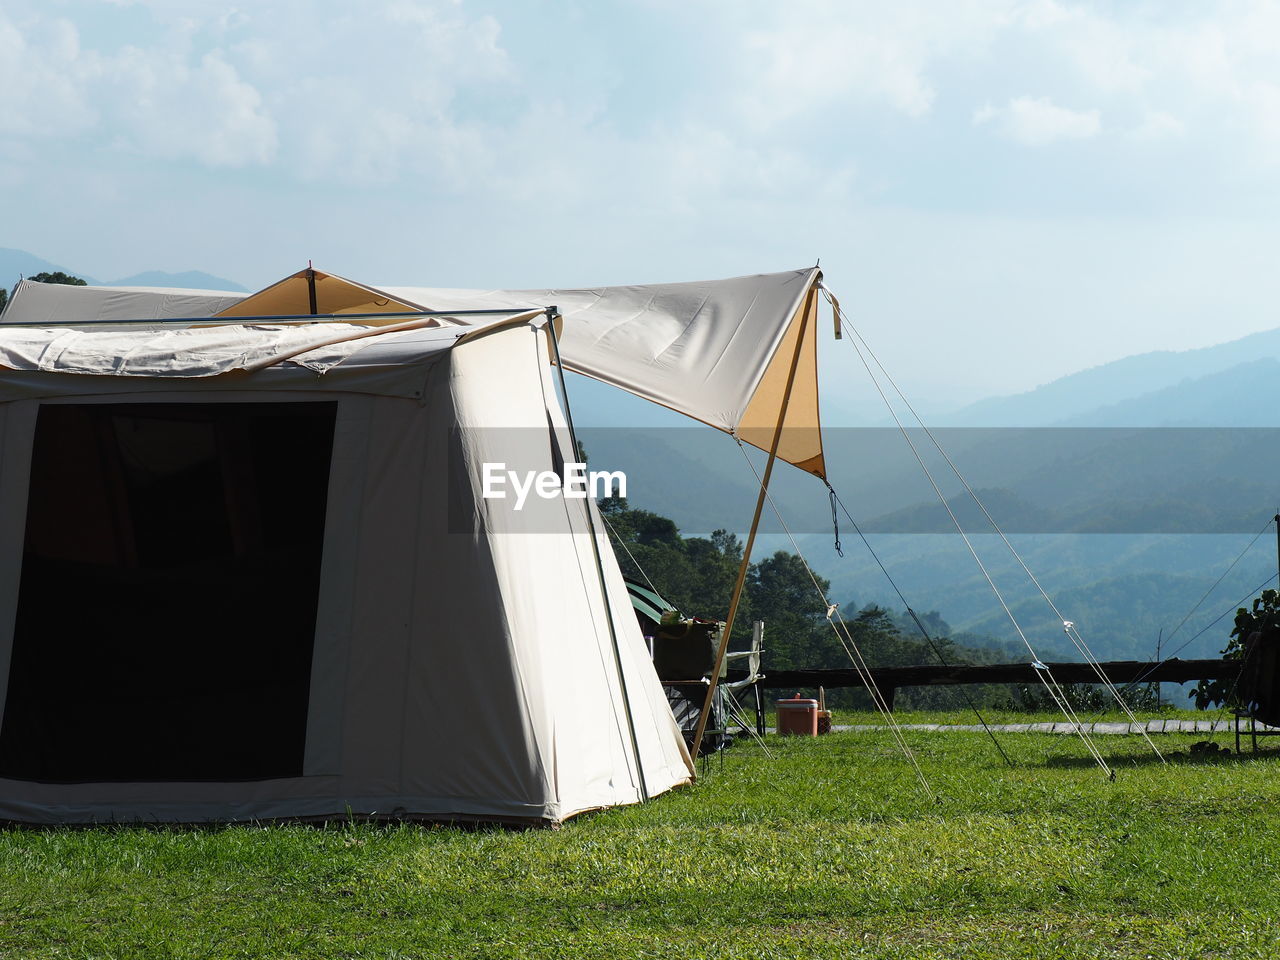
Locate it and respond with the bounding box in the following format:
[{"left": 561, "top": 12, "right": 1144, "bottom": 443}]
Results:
[{"left": 379, "top": 268, "right": 826, "bottom": 476}]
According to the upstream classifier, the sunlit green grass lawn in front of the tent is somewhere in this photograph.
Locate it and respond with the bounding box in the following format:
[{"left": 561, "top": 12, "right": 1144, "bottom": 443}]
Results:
[{"left": 0, "top": 733, "right": 1280, "bottom": 960}]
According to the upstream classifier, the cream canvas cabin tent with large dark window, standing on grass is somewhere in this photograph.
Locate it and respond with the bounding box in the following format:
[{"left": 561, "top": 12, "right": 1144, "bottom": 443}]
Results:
[{"left": 0, "top": 311, "right": 692, "bottom": 823}]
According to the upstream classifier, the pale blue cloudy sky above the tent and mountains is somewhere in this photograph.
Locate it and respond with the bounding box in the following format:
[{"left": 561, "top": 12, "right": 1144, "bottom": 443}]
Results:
[{"left": 0, "top": 0, "right": 1280, "bottom": 407}]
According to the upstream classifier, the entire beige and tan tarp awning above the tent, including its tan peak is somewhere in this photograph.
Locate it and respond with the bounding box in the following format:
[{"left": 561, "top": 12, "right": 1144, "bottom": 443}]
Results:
[{"left": 0, "top": 268, "right": 826, "bottom": 476}]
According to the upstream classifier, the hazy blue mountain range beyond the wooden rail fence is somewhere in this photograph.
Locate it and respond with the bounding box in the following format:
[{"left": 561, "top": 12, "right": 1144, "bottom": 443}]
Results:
[{"left": 590, "top": 305, "right": 1280, "bottom": 675}]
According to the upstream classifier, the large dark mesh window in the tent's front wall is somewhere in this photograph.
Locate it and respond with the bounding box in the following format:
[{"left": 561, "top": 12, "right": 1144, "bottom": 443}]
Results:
[{"left": 0, "top": 403, "right": 337, "bottom": 782}]
